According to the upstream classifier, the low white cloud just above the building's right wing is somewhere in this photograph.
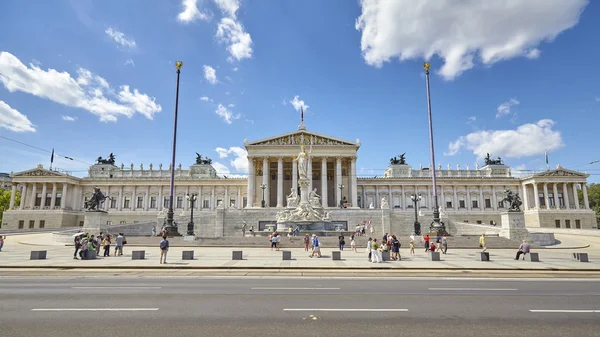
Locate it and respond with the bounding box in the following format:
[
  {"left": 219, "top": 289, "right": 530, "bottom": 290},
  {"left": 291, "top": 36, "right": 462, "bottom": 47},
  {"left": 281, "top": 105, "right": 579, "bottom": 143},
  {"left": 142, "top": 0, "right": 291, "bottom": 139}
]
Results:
[{"left": 444, "top": 119, "right": 564, "bottom": 158}]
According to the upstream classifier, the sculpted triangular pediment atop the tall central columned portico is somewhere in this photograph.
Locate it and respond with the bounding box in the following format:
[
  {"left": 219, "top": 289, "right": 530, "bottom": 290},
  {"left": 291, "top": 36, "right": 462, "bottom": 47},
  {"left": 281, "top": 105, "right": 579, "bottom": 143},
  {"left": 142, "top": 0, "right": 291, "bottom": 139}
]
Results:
[{"left": 244, "top": 130, "right": 360, "bottom": 147}]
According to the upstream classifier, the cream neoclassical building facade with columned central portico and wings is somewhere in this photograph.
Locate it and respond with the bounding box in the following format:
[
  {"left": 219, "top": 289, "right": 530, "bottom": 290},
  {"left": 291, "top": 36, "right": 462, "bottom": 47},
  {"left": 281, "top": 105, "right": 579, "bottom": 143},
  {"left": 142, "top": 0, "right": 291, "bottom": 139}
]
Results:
[{"left": 1, "top": 125, "right": 597, "bottom": 231}]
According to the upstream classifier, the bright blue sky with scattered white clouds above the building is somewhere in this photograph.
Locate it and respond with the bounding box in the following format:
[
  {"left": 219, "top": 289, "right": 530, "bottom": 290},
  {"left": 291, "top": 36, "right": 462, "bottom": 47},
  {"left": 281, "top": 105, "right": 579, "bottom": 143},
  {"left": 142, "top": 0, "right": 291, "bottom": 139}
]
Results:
[{"left": 0, "top": 0, "right": 600, "bottom": 182}]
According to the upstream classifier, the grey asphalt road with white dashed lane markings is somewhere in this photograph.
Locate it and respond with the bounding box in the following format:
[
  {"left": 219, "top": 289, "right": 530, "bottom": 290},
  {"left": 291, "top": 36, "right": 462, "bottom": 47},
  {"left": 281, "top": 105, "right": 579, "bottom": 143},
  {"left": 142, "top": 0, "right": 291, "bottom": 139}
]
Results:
[{"left": 0, "top": 275, "right": 600, "bottom": 337}]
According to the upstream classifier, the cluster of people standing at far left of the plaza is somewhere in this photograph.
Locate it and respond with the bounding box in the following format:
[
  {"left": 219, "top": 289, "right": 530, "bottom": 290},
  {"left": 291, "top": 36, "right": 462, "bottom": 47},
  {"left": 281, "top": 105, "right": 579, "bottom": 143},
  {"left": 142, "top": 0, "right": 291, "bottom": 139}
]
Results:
[{"left": 73, "top": 232, "right": 127, "bottom": 260}]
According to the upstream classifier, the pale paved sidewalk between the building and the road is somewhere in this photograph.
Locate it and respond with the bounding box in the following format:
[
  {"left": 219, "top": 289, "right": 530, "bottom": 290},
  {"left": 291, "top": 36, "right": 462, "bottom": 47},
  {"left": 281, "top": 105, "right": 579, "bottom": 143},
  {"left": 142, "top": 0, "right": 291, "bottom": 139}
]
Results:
[{"left": 0, "top": 234, "right": 600, "bottom": 271}]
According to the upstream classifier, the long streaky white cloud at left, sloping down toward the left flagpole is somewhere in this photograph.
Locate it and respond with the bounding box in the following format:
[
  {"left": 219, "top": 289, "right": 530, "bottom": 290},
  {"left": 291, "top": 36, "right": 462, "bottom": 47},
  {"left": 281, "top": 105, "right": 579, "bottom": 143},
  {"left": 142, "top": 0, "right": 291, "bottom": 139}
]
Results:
[{"left": 0, "top": 52, "right": 162, "bottom": 122}]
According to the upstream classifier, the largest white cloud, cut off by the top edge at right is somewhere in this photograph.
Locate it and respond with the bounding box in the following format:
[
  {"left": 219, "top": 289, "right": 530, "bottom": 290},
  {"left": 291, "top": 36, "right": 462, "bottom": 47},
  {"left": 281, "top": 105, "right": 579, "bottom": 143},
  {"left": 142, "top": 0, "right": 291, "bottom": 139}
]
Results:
[{"left": 355, "top": 0, "right": 589, "bottom": 80}]
